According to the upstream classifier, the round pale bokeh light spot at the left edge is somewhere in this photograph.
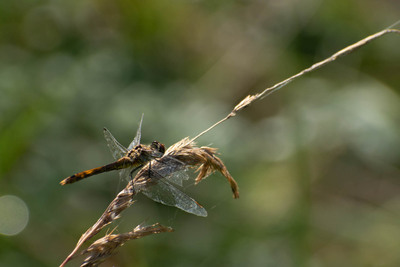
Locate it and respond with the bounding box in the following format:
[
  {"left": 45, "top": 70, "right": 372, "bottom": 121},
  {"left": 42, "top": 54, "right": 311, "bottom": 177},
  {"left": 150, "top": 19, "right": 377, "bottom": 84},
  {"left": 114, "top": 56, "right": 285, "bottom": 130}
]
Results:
[{"left": 0, "top": 195, "right": 29, "bottom": 235}]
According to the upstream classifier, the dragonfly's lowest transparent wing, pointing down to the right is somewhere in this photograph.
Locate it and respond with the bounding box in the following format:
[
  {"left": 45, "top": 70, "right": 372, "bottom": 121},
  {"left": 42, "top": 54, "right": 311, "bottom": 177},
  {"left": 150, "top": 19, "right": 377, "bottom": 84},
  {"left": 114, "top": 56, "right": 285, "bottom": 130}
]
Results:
[{"left": 140, "top": 179, "right": 207, "bottom": 217}]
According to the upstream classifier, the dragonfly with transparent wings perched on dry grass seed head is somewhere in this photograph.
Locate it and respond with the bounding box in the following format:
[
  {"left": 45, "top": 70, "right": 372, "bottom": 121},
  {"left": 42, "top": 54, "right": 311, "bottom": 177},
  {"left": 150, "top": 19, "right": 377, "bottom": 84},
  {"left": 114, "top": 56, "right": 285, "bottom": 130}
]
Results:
[{"left": 60, "top": 116, "right": 207, "bottom": 217}]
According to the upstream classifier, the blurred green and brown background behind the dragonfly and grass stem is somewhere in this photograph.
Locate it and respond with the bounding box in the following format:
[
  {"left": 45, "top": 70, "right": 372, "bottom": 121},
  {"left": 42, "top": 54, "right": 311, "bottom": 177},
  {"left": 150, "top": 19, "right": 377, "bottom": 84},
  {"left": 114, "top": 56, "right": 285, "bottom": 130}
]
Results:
[{"left": 0, "top": 0, "right": 400, "bottom": 267}]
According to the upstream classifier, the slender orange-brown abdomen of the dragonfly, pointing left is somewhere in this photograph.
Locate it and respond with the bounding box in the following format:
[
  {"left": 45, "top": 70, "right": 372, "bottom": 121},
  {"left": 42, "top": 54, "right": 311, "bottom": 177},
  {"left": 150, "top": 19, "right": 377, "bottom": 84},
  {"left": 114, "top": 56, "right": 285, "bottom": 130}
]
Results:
[{"left": 60, "top": 157, "right": 134, "bottom": 185}]
